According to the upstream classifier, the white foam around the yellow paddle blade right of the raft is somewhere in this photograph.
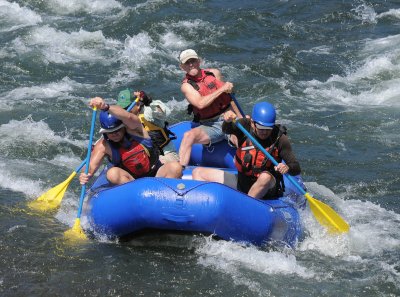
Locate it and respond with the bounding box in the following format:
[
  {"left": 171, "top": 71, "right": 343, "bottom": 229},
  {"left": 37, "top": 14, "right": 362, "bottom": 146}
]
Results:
[{"left": 299, "top": 179, "right": 400, "bottom": 259}]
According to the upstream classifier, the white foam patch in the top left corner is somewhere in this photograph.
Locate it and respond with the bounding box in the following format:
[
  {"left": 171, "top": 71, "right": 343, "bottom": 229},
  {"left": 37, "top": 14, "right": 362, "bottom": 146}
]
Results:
[{"left": 0, "top": 0, "right": 42, "bottom": 32}]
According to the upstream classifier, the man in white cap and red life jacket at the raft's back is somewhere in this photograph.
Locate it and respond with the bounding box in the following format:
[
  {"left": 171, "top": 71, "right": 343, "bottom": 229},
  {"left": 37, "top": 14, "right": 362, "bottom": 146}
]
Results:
[{"left": 179, "top": 49, "right": 240, "bottom": 166}]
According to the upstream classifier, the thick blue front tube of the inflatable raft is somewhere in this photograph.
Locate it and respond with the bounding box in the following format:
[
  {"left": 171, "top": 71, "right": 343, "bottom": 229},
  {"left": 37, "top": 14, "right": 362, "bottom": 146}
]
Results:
[{"left": 88, "top": 178, "right": 300, "bottom": 245}]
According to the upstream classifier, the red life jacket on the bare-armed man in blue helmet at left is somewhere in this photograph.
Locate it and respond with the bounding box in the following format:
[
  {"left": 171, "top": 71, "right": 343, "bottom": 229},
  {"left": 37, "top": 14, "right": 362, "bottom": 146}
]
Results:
[{"left": 108, "top": 134, "right": 158, "bottom": 178}]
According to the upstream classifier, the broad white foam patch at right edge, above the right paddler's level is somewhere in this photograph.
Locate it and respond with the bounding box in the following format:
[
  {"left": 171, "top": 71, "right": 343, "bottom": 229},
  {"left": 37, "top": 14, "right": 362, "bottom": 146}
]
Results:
[{"left": 304, "top": 35, "right": 400, "bottom": 107}]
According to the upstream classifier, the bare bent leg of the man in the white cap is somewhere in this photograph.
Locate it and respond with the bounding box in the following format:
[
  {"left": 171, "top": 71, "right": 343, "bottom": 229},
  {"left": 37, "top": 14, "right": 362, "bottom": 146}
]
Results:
[{"left": 179, "top": 127, "right": 210, "bottom": 166}]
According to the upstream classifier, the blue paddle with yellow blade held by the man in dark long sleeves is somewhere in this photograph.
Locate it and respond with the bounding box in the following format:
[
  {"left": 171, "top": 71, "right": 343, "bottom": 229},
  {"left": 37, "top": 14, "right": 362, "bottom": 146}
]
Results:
[{"left": 235, "top": 121, "right": 350, "bottom": 233}]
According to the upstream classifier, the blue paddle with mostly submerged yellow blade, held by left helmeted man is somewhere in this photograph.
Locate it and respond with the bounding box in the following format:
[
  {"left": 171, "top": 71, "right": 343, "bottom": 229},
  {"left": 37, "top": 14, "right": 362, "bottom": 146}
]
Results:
[{"left": 64, "top": 107, "right": 97, "bottom": 240}]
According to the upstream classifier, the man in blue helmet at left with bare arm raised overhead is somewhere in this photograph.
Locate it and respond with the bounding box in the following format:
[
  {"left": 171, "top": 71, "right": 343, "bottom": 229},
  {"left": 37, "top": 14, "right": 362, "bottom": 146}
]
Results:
[{"left": 79, "top": 97, "right": 182, "bottom": 184}]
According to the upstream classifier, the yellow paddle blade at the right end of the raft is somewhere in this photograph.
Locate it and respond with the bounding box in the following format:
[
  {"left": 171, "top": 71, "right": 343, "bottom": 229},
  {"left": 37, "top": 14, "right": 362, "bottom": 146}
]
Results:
[{"left": 304, "top": 193, "right": 350, "bottom": 233}]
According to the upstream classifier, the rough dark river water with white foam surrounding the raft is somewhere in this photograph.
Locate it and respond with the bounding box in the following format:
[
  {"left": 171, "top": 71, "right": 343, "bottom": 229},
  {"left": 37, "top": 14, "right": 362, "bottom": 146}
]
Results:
[{"left": 0, "top": 0, "right": 400, "bottom": 296}]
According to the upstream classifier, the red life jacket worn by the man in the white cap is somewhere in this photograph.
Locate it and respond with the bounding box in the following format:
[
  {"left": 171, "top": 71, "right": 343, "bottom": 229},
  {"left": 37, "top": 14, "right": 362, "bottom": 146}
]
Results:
[{"left": 182, "top": 69, "right": 232, "bottom": 122}]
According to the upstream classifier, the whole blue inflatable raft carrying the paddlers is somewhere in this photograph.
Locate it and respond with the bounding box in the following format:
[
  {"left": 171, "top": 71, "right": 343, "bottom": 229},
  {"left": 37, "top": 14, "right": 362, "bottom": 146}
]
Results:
[{"left": 84, "top": 122, "right": 304, "bottom": 246}]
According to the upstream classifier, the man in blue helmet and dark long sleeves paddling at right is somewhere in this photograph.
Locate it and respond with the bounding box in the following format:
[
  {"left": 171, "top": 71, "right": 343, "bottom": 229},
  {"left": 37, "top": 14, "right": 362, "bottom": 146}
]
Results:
[{"left": 193, "top": 102, "right": 301, "bottom": 199}]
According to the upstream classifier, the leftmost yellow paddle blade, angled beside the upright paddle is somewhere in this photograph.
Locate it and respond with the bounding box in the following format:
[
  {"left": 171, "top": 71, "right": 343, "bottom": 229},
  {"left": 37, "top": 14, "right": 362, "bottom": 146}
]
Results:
[{"left": 28, "top": 171, "right": 76, "bottom": 211}]
